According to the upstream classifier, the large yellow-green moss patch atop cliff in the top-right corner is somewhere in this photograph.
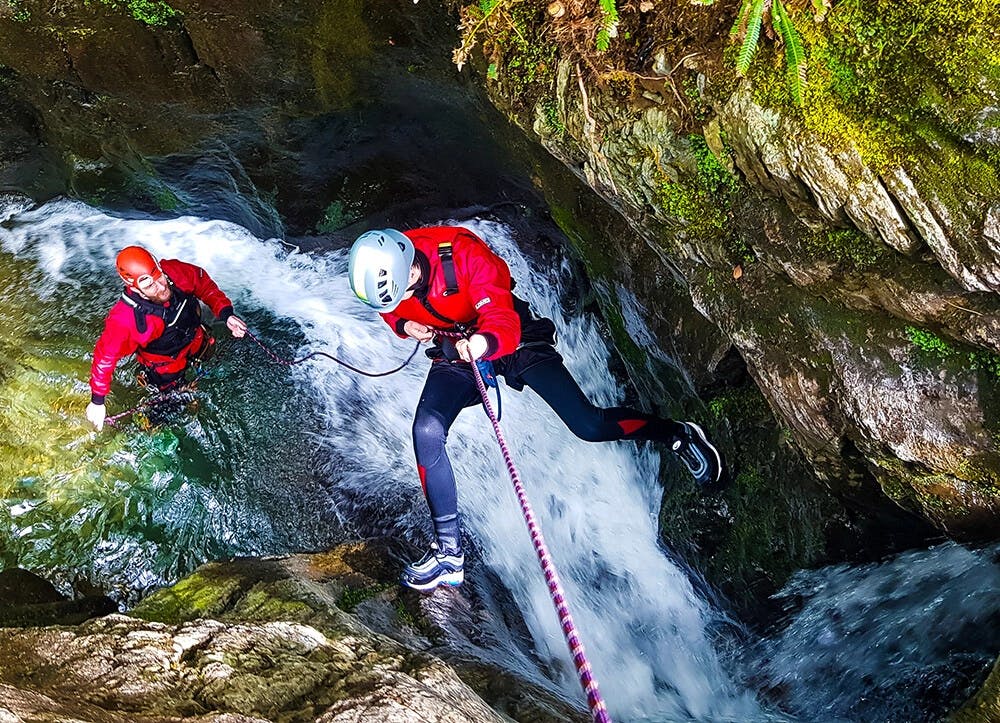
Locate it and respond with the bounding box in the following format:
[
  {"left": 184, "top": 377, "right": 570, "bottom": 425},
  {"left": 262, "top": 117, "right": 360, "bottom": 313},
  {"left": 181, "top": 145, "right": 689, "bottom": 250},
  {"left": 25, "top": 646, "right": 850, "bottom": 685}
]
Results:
[{"left": 750, "top": 0, "right": 1000, "bottom": 185}]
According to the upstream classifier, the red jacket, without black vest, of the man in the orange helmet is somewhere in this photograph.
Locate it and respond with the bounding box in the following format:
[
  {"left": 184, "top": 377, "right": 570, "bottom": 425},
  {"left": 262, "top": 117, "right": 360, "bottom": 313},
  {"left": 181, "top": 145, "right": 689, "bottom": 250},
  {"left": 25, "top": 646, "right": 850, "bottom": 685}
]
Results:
[{"left": 90, "top": 259, "right": 233, "bottom": 404}]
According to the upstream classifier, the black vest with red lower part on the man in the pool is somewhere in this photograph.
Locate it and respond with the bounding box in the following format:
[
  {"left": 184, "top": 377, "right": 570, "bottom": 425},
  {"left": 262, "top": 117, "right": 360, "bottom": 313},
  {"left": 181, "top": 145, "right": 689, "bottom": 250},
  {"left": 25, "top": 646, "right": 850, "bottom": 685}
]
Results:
[{"left": 122, "top": 277, "right": 205, "bottom": 372}]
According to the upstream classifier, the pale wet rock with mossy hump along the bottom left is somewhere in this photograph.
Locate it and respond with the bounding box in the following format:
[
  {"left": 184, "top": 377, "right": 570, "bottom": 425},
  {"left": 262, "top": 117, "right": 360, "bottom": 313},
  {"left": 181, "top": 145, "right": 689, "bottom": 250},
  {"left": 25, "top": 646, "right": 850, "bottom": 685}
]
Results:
[{"left": 0, "top": 541, "right": 586, "bottom": 723}]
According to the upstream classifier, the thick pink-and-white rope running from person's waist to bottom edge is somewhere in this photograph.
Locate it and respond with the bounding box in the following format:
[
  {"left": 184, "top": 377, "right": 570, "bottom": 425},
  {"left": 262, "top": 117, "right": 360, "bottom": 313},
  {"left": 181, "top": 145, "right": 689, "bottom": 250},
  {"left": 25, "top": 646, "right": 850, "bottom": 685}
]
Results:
[{"left": 472, "top": 364, "right": 611, "bottom": 723}]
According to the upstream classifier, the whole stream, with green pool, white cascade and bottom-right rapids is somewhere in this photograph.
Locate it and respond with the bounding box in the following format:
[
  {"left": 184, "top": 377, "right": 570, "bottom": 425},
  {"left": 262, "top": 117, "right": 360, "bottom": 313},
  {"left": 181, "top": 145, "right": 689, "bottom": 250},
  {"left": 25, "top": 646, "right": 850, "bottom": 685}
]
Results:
[{"left": 0, "top": 199, "right": 998, "bottom": 721}]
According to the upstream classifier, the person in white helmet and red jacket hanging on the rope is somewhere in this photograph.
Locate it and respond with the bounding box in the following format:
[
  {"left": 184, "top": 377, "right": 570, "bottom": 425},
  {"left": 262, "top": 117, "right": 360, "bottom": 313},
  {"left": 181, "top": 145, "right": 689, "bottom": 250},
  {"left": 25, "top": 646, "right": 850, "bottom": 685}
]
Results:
[{"left": 348, "top": 226, "right": 722, "bottom": 590}]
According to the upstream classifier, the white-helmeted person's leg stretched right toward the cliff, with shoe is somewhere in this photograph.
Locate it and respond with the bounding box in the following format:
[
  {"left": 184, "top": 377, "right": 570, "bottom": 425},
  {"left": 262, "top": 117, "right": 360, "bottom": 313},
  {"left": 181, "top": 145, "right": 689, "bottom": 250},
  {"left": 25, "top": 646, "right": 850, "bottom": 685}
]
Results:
[{"left": 521, "top": 359, "right": 722, "bottom": 485}]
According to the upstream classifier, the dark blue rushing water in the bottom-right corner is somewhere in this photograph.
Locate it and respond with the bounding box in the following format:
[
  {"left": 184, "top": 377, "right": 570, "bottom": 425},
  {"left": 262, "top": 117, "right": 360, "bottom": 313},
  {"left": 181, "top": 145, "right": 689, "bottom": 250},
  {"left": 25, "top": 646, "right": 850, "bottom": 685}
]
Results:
[{"left": 748, "top": 543, "right": 1000, "bottom": 721}]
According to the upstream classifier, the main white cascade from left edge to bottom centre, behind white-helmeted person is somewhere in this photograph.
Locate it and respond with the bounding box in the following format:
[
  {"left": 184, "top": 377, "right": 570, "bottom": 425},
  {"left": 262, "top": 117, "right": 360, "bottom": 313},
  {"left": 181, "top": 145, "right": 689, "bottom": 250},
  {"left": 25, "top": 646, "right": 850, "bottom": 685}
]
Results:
[{"left": 0, "top": 201, "right": 756, "bottom": 720}]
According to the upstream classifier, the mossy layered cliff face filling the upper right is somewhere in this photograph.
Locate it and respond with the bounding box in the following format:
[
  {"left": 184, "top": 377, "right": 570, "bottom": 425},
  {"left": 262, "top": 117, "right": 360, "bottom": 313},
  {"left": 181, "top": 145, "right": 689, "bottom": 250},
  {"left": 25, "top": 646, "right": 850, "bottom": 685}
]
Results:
[{"left": 465, "top": 2, "right": 1000, "bottom": 537}]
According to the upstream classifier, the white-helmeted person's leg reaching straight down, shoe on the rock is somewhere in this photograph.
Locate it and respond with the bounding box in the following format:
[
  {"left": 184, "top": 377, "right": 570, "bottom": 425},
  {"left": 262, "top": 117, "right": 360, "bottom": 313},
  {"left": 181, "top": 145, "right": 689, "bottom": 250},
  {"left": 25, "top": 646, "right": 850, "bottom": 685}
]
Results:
[{"left": 401, "top": 362, "right": 479, "bottom": 590}]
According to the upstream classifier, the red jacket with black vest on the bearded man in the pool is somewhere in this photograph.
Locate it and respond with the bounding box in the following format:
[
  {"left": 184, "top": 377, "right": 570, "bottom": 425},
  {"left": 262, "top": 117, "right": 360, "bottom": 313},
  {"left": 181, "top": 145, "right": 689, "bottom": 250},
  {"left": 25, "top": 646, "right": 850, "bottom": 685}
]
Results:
[{"left": 90, "top": 259, "right": 233, "bottom": 404}]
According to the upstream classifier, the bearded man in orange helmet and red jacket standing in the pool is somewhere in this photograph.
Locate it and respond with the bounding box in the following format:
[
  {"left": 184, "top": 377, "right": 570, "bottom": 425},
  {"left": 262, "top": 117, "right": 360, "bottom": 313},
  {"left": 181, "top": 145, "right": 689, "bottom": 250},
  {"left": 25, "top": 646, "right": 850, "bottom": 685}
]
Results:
[{"left": 86, "top": 246, "right": 247, "bottom": 430}]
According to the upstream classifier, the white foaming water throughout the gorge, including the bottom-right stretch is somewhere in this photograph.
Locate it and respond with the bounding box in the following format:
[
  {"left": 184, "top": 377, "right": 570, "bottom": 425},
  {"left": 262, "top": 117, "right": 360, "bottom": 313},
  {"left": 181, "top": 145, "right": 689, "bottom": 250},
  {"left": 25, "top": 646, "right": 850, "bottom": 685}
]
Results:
[{"left": 0, "top": 195, "right": 996, "bottom": 721}]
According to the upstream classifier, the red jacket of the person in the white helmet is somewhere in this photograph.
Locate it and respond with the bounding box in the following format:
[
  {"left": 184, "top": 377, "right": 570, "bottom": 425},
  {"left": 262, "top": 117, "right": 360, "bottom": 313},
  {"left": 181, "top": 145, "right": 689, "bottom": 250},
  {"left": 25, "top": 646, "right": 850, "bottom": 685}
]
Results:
[{"left": 382, "top": 226, "right": 521, "bottom": 359}]
